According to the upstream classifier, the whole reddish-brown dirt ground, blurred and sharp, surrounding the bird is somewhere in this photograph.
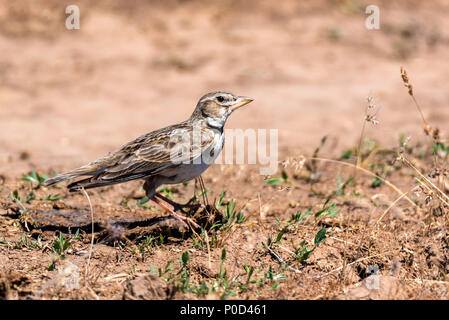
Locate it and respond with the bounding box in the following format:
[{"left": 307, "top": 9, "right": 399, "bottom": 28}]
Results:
[{"left": 0, "top": 0, "right": 449, "bottom": 299}]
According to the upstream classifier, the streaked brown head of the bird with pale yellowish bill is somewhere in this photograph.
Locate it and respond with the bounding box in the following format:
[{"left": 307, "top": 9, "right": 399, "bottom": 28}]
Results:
[{"left": 192, "top": 91, "right": 253, "bottom": 128}]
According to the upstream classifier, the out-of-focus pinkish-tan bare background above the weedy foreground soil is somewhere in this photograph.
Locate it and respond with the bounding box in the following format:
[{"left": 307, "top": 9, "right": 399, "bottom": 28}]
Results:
[{"left": 0, "top": 0, "right": 449, "bottom": 176}]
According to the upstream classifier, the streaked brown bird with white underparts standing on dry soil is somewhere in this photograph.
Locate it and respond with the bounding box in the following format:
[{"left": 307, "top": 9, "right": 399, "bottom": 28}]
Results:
[{"left": 44, "top": 91, "right": 254, "bottom": 228}]
